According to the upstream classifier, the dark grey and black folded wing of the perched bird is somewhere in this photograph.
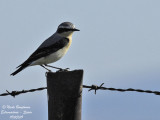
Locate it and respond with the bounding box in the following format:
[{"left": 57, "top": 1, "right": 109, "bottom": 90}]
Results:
[{"left": 18, "top": 36, "right": 69, "bottom": 67}]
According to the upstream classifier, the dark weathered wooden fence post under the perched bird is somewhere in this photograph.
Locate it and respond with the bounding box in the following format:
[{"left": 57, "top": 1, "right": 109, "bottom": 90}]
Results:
[{"left": 47, "top": 70, "right": 83, "bottom": 120}]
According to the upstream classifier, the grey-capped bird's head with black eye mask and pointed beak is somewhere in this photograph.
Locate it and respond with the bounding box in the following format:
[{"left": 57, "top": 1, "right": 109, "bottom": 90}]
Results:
[{"left": 57, "top": 22, "right": 80, "bottom": 37}]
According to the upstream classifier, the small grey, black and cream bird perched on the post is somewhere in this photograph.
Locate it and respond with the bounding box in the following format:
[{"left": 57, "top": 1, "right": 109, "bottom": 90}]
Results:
[{"left": 10, "top": 22, "right": 80, "bottom": 76}]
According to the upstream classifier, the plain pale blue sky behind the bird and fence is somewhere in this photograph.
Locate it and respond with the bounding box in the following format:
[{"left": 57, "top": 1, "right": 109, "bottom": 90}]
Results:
[{"left": 0, "top": 0, "right": 160, "bottom": 120}]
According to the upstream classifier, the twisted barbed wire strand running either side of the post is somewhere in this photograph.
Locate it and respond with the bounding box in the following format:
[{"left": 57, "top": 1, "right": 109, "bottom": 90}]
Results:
[{"left": 0, "top": 83, "right": 160, "bottom": 97}]
